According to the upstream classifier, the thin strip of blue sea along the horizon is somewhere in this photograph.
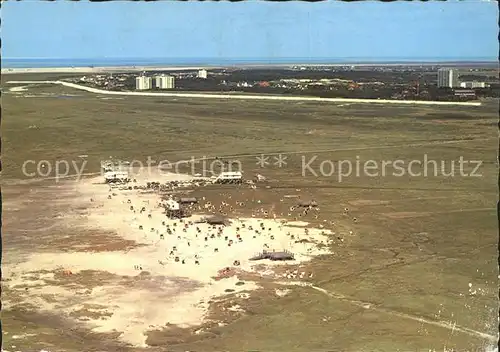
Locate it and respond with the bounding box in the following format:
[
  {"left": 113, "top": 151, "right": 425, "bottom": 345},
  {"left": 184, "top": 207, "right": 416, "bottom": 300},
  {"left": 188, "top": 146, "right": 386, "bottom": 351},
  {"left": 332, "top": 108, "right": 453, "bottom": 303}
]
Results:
[{"left": 1, "top": 58, "right": 498, "bottom": 69}]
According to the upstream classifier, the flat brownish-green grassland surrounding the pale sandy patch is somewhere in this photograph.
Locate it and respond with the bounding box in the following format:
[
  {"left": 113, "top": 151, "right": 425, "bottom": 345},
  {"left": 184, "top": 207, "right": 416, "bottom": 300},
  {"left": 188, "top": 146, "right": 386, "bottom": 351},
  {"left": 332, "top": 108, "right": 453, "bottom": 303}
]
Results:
[{"left": 2, "top": 77, "right": 498, "bottom": 351}]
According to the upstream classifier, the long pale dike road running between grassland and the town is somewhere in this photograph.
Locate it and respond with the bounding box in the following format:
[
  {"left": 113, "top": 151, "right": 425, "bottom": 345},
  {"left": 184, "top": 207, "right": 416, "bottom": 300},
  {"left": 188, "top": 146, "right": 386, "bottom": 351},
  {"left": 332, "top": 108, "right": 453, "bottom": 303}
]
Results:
[{"left": 7, "top": 81, "right": 481, "bottom": 106}]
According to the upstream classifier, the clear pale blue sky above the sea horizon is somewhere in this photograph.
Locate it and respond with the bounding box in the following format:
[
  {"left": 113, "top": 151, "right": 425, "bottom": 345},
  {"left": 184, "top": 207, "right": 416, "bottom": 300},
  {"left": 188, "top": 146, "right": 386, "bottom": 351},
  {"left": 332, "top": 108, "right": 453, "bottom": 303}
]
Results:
[{"left": 0, "top": 0, "right": 499, "bottom": 61}]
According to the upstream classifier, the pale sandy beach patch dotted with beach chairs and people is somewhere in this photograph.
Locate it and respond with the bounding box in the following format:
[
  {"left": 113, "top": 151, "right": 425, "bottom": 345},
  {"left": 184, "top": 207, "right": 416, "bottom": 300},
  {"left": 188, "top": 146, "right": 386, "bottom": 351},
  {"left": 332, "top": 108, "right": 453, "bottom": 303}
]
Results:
[{"left": 6, "top": 169, "right": 329, "bottom": 346}]
